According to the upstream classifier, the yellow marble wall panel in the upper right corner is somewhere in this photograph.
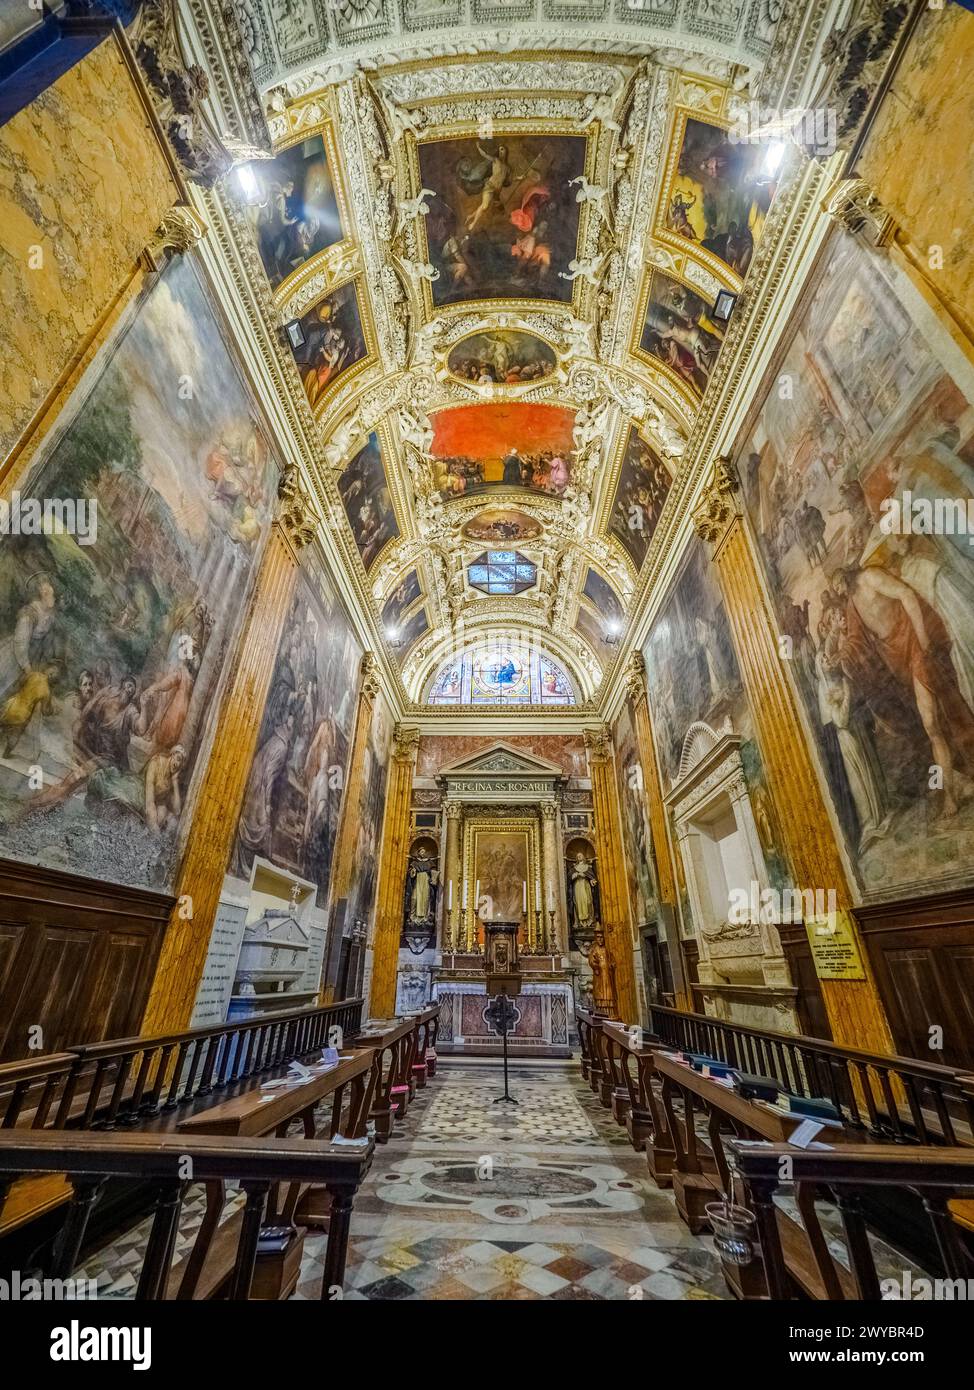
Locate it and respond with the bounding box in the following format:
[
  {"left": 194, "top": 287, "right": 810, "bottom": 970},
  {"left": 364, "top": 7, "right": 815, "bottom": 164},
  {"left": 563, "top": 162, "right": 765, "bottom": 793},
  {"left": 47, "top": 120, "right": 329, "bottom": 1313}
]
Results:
[{"left": 856, "top": 6, "right": 974, "bottom": 344}]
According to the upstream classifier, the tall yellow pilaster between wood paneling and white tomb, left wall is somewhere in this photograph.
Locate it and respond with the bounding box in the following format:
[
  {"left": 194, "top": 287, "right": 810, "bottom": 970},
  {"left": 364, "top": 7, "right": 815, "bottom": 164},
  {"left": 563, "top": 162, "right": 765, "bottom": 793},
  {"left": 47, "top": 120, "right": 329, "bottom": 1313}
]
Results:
[{"left": 142, "top": 464, "right": 317, "bottom": 1034}]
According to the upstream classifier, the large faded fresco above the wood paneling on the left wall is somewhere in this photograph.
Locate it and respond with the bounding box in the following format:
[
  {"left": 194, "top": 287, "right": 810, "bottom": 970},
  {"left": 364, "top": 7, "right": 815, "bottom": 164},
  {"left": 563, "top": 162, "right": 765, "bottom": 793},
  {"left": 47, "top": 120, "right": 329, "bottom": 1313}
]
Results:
[{"left": 0, "top": 261, "right": 278, "bottom": 888}]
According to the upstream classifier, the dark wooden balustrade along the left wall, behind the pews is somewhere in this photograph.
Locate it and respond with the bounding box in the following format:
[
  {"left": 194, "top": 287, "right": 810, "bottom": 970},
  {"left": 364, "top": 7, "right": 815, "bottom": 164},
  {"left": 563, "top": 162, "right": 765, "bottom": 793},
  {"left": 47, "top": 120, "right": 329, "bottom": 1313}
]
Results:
[{"left": 0, "top": 999, "right": 363, "bottom": 1130}]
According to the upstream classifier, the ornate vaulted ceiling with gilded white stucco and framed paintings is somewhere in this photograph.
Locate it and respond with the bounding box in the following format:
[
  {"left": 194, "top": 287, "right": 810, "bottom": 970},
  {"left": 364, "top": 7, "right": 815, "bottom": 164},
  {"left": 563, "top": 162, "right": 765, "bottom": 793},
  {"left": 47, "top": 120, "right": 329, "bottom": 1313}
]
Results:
[{"left": 190, "top": 0, "right": 822, "bottom": 703}]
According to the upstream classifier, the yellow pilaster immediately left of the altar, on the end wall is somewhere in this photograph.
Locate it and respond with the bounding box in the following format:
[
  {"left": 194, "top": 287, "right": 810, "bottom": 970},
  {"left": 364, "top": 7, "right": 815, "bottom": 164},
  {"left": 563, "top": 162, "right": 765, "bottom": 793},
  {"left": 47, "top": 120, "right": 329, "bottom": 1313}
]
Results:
[{"left": 368, "top": 724, "right": 420, "bottom": 1019}]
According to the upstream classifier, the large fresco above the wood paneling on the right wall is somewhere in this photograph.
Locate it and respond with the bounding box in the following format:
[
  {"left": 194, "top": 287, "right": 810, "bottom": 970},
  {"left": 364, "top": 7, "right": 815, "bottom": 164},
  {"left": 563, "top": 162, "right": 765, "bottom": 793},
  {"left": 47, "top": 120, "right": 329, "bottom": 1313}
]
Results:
[{"left": 735, "top": 227, "right": 974, "bottom": 895}]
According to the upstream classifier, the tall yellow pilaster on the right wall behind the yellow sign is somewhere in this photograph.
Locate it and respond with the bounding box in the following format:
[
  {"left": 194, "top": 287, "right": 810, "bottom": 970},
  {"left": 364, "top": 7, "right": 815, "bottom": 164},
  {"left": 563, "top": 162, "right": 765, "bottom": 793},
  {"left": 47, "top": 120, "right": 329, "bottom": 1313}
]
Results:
[{"left": 693, "top": 459, "right": 893, "bottom": 1052}]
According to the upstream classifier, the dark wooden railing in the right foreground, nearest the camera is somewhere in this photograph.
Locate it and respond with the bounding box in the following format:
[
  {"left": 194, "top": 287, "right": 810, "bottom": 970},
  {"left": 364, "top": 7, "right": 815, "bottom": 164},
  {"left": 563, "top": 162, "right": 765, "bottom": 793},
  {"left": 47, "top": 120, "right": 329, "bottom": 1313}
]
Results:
[{"left": 728, "top": 1140, "right": 974, "bottom": 1300}]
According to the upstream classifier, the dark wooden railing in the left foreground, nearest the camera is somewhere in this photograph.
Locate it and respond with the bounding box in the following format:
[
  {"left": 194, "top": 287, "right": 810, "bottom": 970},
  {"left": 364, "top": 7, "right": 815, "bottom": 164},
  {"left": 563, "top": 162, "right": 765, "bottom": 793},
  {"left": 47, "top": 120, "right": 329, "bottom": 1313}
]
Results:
[{"left": 0, "top": 1129, "right": 372, "bottom": 1300}]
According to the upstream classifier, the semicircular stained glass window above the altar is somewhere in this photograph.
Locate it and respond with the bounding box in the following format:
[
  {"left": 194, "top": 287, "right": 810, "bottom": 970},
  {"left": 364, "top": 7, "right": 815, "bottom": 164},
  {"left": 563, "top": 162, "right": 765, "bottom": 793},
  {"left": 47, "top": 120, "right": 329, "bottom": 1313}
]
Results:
[{"left": 427, "top": 637, "right": 575, "bottom": 705}]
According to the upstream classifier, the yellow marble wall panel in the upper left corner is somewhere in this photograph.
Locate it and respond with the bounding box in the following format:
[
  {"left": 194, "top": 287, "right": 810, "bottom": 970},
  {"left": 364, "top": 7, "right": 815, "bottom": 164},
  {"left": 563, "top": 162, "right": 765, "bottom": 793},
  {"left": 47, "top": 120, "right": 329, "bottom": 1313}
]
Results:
[{"left": 0, "top": 36, "right": 185, "bottom": 459}]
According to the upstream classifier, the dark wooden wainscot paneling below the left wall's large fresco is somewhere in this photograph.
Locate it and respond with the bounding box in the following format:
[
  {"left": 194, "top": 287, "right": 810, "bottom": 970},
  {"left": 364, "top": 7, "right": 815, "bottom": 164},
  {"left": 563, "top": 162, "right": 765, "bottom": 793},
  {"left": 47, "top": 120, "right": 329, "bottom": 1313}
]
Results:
[{"left": 0, "top": 859, "right": 174, "bottom": 1062}]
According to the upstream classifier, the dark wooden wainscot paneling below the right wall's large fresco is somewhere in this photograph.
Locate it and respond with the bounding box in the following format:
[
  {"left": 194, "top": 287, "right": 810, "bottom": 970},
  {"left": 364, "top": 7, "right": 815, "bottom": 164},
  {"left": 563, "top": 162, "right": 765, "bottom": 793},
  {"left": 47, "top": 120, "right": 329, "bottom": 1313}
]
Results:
[{"left": 855, "top": 888, "right": 974, "bottom": 1070}]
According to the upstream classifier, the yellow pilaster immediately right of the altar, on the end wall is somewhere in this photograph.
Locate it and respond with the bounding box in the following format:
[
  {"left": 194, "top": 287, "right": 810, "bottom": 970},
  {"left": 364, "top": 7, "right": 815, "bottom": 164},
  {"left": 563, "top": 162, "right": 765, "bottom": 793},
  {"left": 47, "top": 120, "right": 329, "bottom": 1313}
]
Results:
[{"left": 585, "top": 727, "right": 639, "bottom": 1023}]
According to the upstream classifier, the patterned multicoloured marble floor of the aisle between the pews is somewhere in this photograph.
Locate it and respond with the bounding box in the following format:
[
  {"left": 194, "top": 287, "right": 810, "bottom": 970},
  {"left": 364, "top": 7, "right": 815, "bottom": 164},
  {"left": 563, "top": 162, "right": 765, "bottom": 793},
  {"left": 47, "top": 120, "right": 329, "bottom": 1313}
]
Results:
[{"left": 297, "top": 1058, "right": 728, "bottom": 1300}]
